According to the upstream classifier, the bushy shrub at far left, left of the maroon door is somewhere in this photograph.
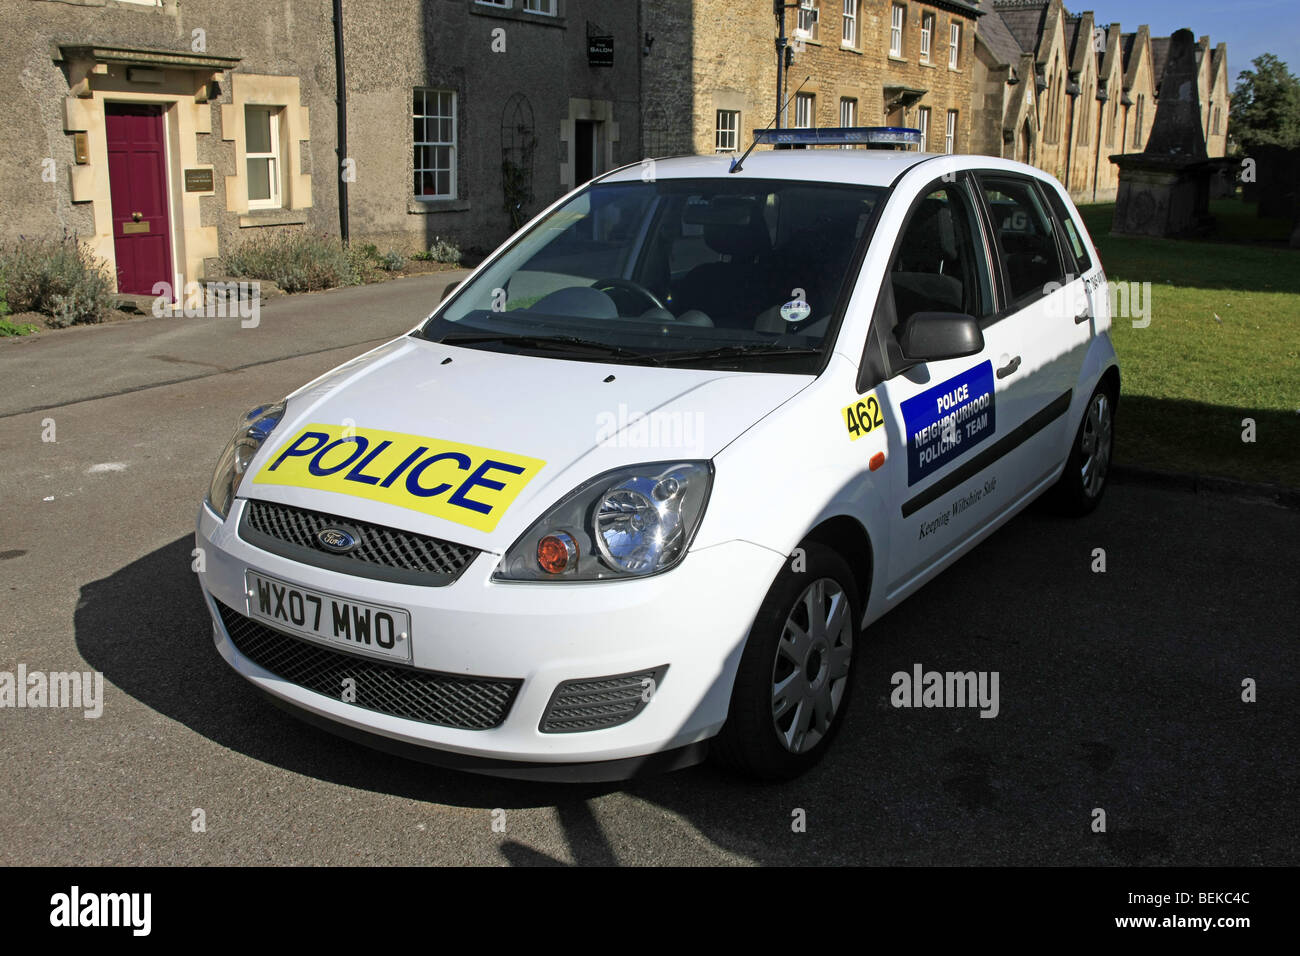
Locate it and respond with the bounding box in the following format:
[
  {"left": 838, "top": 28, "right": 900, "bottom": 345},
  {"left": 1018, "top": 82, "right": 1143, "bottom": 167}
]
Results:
[{"left": 0, "top": 233, "right": 114, "bottom": 328}]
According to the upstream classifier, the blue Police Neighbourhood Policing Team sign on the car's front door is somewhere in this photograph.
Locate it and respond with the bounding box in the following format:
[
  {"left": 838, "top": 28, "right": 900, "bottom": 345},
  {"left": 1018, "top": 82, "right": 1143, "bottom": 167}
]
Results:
[{"left": 902, "top": 362, "right": 996, "bottom": 488}]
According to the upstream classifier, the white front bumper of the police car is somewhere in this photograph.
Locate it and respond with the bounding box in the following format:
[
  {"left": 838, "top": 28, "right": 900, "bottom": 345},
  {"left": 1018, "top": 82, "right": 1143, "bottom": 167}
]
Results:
[{"left": 196, "top": 499, "right": 784, "bottom": 779}]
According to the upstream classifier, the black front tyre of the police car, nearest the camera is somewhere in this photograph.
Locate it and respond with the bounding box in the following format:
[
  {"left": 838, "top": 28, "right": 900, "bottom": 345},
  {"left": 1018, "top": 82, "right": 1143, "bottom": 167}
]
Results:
[{"left": 712, "top": 542, "right": 862, "bottom": 780}]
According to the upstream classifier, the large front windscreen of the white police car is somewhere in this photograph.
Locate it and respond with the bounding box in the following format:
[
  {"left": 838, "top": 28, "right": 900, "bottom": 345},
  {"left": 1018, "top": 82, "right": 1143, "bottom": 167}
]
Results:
[{"left": 420, "top": 178, "right": 884, "bottom": 373}]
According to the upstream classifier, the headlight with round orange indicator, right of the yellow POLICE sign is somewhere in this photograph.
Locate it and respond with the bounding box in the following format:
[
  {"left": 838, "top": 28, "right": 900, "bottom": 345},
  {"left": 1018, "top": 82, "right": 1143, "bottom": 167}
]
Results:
[{"left": 494, "top": 462, "right": 714, "bottom": 581}]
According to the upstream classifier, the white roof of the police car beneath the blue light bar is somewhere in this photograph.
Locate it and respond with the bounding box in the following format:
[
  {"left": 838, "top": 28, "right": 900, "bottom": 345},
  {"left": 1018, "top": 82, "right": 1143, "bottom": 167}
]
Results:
[{"left": 597, "top": 147, "right": 1052, "bottom": 187}]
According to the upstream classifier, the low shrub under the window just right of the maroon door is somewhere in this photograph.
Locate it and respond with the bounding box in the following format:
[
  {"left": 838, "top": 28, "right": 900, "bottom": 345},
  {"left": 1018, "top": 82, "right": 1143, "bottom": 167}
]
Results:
[{"left": 222, "top": 232, "right": 358, "bottom": 293}]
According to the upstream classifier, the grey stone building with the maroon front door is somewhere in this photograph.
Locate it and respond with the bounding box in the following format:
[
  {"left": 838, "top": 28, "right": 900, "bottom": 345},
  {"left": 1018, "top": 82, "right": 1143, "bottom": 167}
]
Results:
[{"left": 0, "top": 0, "right": 644, "bottom": 294}]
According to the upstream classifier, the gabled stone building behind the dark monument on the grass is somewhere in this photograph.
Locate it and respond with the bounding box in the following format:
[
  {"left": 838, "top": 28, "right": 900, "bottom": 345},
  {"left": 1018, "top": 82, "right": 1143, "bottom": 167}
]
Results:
[{"left": 972, "top": 0, "right": 1230, "bottom": 202}]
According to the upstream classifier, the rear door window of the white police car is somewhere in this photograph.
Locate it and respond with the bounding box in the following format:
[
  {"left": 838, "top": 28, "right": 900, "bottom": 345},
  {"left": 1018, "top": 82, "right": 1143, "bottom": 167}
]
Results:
[{"left": 980, "top": 176, "right": 1065, "bottom": 304}]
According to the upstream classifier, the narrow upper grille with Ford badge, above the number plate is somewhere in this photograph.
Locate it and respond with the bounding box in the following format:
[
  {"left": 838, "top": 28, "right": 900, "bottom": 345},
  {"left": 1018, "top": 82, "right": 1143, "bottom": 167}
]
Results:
[{"left": 239, "top": 501, "right": 478, "bottom": 585}]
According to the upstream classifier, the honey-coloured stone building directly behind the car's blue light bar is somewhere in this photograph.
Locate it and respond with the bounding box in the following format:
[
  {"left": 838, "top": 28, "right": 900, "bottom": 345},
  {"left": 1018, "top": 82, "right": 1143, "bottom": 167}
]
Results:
[{"left": 642, "top": 0, "right": 978, "bottom": 156}]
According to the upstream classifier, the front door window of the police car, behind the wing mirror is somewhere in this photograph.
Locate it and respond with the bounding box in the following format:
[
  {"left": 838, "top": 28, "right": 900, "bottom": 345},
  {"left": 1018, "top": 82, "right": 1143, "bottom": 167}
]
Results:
[{"left": 887, "top": 182, "right": 993, "bottom": 335}]
